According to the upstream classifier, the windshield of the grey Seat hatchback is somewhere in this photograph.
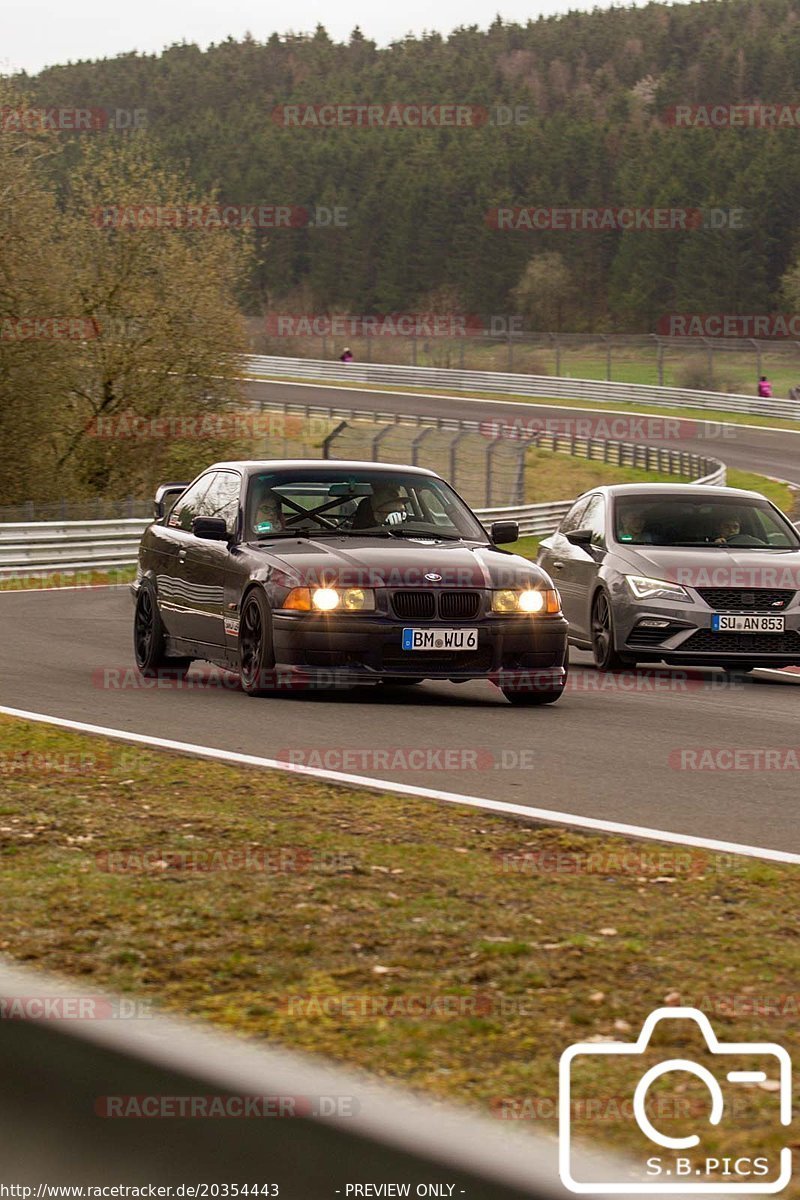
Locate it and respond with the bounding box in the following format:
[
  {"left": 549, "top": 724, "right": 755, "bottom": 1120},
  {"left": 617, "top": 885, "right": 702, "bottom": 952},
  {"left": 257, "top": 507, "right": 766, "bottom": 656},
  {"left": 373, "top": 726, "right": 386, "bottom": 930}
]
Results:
[{"left": 614, "top": 496, "right": 800, "bottom": 550}]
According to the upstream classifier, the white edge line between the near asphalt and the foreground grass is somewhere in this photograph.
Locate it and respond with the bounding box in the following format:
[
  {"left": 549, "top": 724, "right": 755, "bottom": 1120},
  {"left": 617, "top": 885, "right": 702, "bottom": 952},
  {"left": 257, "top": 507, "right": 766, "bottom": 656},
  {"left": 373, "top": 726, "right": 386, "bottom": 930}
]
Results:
[{"left": 0, "top": 704, "right": 800, "bottom": 865}]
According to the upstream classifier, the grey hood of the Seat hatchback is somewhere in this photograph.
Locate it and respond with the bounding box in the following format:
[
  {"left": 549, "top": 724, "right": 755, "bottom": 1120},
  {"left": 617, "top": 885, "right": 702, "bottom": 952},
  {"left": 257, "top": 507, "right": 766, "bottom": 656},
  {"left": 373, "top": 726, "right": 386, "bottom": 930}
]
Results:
[{"left": 613, "top": 546, "right": 800, "bottom": 589}]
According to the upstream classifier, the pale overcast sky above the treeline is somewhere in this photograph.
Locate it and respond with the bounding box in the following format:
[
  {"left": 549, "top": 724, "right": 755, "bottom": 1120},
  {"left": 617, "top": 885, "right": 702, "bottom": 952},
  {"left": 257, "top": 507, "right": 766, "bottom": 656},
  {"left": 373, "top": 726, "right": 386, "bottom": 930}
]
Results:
[{"left": 6, "top": 0, "right": 633, "bottom": 73}]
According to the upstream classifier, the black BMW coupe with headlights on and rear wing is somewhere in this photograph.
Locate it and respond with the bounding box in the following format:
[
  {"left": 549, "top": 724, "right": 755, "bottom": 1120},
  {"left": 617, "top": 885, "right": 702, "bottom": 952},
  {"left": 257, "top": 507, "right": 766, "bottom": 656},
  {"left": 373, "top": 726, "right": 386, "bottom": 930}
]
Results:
[{"left": 132, "top": 460, "right": 567, "bottom": 704}]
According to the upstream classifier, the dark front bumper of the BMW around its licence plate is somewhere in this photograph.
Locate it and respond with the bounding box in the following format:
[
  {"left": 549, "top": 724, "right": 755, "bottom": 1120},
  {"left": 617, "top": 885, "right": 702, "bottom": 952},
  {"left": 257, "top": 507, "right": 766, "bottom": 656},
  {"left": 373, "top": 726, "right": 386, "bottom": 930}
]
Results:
[{"left": 272, "top": 610, "right": 569, "bottom": 688}]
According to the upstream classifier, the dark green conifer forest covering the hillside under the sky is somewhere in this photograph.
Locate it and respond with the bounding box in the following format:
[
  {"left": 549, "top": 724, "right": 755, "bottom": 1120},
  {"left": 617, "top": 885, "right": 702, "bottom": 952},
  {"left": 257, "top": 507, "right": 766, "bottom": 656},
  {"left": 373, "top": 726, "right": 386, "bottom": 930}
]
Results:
[{"left": 13, "top": 0, "right": 800, "bottom": 331}]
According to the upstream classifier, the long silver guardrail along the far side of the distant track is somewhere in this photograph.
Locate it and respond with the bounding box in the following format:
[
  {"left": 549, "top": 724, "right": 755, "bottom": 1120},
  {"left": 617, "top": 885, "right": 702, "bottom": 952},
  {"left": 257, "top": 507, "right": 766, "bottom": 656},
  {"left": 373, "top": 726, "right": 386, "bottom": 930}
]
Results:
[{"left": 243, "top": 354, "right": 800, "bottom": 421}]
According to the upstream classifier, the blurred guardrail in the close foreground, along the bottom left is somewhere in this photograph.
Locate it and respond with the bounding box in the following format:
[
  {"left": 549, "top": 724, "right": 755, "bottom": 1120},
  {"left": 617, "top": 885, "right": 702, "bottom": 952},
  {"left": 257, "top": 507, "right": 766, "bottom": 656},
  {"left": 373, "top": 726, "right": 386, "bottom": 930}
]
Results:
[{"left": 0, "top": 964, "right": 647, "bottom": 1200}]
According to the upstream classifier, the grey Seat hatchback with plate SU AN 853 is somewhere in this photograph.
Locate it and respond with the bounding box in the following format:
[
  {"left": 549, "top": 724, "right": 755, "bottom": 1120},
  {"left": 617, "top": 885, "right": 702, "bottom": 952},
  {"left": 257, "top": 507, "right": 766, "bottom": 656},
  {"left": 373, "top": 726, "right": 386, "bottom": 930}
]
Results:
[{"left": 537, "top": 484, "right": 800, "bottom": 671}]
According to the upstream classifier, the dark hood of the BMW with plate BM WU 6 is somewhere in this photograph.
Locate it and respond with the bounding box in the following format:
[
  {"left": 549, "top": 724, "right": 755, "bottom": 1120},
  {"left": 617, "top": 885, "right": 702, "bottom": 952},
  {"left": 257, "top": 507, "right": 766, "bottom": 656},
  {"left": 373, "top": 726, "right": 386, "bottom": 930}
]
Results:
[{"left": 249, "top": 536, "right": 549, "bottom": 588}]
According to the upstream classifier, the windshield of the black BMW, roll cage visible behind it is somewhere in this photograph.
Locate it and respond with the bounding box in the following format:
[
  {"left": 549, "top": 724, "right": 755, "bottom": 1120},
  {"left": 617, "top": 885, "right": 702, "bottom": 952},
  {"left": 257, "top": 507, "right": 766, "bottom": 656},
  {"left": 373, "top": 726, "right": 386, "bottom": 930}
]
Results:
[{"left": 247, "top": 466, "right": 487, "bottom": 541}]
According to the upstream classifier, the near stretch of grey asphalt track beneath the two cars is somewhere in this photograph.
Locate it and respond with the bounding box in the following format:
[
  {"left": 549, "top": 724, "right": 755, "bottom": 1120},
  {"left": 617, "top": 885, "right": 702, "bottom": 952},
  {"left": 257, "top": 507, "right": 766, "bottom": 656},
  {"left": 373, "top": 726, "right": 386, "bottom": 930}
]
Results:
[{"left": 0, "top": 587, "right": 800, "bottom": 853}]
